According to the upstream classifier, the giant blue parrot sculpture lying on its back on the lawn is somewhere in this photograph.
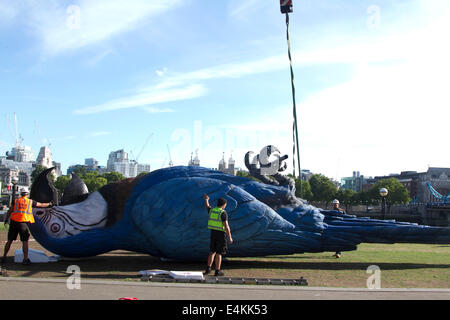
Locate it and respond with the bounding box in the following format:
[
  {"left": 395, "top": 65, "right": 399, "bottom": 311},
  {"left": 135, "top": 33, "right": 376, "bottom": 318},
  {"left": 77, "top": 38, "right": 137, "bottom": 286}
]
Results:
[{"left": 30, "top": 148, "right": 450, "bottom": 261}]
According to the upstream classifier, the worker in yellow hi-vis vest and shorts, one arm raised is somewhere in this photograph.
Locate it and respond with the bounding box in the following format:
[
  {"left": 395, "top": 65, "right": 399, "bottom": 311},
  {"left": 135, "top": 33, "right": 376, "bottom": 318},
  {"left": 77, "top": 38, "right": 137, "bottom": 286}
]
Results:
[{"left": 203, "top": 194, "right": 233, "bottom": 276}]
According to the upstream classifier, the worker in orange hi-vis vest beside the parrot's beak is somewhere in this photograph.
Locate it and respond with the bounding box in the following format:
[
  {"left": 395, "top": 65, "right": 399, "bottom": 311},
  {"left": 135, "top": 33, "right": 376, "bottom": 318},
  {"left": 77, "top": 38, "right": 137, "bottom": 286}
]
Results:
[{"left": 1, "top": 187, "right": 51, "bottom": 265}]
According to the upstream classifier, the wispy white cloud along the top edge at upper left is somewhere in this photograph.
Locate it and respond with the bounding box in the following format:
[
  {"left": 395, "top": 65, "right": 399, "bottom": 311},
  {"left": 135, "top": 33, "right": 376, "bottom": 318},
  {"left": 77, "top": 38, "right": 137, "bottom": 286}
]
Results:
[{"left": 9, "top": 0, "right": 184, "bottom": 56}]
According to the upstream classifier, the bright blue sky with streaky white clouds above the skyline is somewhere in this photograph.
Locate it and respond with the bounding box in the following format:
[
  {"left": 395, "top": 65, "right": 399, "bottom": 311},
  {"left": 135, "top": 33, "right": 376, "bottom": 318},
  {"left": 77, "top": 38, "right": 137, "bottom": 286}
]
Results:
[{"left": 0, "top": 0, "right": 450, "bottom": 180}]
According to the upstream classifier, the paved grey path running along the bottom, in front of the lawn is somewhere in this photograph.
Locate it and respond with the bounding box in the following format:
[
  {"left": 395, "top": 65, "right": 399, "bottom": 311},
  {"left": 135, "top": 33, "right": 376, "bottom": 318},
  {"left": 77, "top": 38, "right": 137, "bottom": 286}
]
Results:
[{"left": 0, "top": 277, "right": 450, "bottom": 300}]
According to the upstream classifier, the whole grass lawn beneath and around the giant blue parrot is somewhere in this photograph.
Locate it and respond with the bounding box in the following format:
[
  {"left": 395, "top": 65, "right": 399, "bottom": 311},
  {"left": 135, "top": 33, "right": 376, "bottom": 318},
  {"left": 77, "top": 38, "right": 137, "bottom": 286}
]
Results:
[{"left": 0, "top": 224, "right": 450, "bottom": 289}]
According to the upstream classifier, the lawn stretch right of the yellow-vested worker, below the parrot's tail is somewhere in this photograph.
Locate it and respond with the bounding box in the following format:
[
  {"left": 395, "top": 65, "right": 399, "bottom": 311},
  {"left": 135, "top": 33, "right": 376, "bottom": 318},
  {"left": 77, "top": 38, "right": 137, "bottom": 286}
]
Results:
[{"left": 225, "top": 244, "right": 450, "bottom": 288}]
